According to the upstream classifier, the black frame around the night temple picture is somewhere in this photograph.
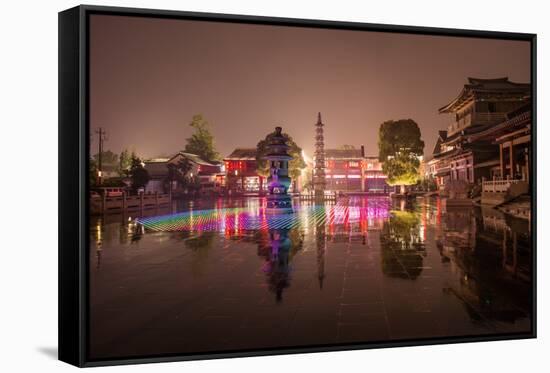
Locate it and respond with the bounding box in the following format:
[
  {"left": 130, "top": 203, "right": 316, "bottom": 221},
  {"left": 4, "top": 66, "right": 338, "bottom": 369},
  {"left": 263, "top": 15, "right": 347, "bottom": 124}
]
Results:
[{"left": 58, "top": 5, "right": 537, "bottom": 367}]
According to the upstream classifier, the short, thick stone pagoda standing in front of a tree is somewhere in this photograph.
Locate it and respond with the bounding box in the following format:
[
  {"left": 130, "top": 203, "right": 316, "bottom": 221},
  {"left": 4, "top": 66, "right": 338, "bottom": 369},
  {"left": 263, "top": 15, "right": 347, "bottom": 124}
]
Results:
[{"left": 264, "top": 127, "right": 292, "bottom": 213}]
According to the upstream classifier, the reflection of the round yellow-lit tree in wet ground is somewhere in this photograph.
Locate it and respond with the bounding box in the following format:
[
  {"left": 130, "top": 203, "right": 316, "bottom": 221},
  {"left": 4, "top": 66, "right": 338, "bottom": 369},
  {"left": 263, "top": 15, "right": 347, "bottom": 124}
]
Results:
[{"left": 380, "top": 211, "right": 425, "bottom": 280}]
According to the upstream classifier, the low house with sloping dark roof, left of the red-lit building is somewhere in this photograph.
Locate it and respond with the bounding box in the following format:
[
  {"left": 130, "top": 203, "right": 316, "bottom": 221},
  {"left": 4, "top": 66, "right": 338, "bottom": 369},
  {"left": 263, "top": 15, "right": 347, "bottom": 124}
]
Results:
[{"left": 144, "top": 152, "right": 223, "bottom": 192}]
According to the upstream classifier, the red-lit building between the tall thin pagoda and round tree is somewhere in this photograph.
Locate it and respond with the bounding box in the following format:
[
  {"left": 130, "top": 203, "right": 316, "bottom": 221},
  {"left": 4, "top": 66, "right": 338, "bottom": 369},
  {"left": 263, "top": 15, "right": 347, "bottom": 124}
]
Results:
[{"left": 325, "top": 146, "right": 389, "bottom": 193}]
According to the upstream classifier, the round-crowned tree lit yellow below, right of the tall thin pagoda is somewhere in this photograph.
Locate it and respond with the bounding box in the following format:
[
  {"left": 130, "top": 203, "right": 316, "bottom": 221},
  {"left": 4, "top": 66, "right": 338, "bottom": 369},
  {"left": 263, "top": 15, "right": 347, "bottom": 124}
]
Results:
[{"left": 378, "top": 119, "right": 424, "bottom": 193}]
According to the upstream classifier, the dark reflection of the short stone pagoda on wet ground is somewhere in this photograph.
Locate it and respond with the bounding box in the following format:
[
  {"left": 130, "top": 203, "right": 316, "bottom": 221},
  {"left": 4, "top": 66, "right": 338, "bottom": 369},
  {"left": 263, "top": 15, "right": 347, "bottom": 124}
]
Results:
[{"left": 257, "top": 225, "right": 304, "bottom": 302}]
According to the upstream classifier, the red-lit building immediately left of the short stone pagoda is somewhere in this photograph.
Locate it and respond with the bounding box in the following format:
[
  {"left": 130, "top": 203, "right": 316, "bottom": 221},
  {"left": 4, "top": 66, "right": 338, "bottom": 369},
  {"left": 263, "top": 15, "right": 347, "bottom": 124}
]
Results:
[{"left": 223, "top": 148, "right": 267, "bottom": 193}]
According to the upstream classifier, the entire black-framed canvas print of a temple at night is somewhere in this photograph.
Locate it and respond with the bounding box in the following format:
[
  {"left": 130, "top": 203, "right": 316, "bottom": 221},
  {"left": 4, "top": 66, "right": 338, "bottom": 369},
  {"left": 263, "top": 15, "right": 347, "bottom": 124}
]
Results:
[{"left": 59, "top": 6, "right": 536, "bottom": 367}]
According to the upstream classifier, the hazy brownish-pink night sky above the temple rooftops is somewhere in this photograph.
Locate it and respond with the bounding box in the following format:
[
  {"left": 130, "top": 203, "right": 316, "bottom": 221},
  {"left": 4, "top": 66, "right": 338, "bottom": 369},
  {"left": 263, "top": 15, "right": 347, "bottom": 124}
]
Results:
[{"left": 90, "top": 15, "right": 530, "bottom": 158}]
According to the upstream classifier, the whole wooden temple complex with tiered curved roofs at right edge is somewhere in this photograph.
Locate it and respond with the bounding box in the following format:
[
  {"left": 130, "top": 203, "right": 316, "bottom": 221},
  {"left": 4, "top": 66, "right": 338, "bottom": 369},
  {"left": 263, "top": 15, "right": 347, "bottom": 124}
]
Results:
[{"left": 428, "top": 78, "right": 531, "bottom": 201}]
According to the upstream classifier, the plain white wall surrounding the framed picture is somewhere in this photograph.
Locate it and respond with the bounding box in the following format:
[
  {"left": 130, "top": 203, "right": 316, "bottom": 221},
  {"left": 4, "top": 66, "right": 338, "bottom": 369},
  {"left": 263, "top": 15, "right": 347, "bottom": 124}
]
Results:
[{"left": 0, "top": 0, "right": 550, "bottom": 373}]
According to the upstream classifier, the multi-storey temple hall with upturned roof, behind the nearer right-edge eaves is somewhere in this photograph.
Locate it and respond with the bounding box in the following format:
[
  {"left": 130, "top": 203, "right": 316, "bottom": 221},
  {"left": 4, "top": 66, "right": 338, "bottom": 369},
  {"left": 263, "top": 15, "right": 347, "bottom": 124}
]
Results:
[{"left": 432, "top": 78, "right": 531, "bottom": 185}]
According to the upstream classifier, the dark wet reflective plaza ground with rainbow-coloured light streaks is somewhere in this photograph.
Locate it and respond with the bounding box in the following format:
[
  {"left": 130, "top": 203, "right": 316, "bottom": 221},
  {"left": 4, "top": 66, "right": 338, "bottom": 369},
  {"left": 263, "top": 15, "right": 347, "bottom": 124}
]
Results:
[{"left": 90, "top": 197, "right": 531, "bottom": 359}]
